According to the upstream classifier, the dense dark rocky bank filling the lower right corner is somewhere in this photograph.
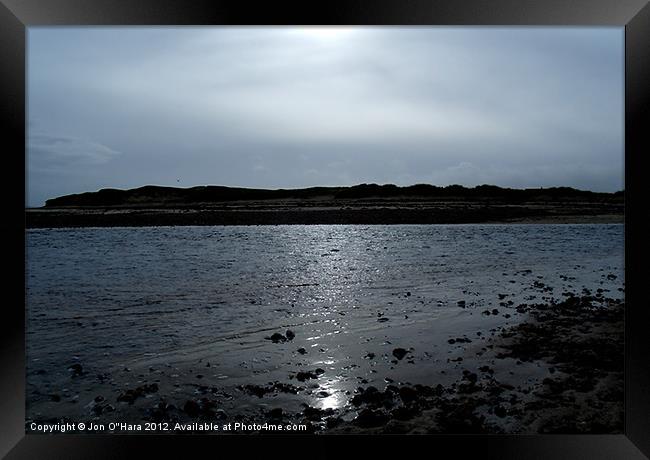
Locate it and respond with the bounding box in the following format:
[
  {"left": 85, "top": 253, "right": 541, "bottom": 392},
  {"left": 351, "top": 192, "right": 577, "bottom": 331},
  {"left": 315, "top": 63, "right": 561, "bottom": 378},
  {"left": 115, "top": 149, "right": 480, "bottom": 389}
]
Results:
[{"left": 332, "top": 293, "right": 624, "bottom": 434}]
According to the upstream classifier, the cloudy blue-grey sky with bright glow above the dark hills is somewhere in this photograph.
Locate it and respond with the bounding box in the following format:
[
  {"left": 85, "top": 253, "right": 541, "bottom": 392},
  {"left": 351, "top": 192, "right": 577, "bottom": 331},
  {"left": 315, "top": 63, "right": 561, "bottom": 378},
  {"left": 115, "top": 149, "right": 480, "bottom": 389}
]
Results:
[{"left": 26, "top": 27, "right": 624, "bottom": 207}]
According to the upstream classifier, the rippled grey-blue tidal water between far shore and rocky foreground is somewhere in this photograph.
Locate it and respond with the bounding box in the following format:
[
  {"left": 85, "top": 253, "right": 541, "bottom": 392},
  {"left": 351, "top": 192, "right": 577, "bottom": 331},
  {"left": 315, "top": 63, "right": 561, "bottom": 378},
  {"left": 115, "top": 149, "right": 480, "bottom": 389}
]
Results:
[{"left": 26, "top": 224, "right": 624, "bottom": 426}]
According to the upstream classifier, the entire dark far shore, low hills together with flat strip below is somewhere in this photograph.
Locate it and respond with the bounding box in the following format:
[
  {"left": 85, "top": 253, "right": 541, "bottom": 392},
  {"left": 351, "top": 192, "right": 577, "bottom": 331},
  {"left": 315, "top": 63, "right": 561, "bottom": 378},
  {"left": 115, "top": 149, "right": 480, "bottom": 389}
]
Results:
[{"left": 26, "top": 184, "right": 624, "bottom": 228}]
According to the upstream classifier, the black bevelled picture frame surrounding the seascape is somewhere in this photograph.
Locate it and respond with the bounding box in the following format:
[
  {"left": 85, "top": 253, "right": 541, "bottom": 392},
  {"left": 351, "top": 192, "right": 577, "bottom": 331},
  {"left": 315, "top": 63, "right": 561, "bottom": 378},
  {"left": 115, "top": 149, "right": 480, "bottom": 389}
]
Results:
[{"left": 0, "top": 0, "right": 650, "bottom": 459}]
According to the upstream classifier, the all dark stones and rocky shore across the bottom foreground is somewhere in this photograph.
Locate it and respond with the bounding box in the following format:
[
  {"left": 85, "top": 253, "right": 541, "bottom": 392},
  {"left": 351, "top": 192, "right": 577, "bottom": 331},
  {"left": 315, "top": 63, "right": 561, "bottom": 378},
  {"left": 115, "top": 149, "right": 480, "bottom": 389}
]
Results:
[{"left": 26, "top": 294, "right": 624, "bottom": 434}]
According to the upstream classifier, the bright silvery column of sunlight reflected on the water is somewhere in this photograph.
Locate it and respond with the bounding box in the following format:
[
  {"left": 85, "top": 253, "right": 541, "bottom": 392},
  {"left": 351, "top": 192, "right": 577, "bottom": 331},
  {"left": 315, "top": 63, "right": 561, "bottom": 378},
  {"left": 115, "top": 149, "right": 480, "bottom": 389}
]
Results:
[{"left": 282, "top": 225, "right": 372, "bottom": 410}]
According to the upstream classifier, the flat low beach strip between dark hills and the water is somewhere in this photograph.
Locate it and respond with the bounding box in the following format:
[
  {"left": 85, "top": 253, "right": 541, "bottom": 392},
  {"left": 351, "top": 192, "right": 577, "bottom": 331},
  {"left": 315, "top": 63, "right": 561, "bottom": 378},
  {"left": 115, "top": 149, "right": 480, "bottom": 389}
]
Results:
[{"left": 26, "top": 203, "right": 624, "bottom": 228}]
